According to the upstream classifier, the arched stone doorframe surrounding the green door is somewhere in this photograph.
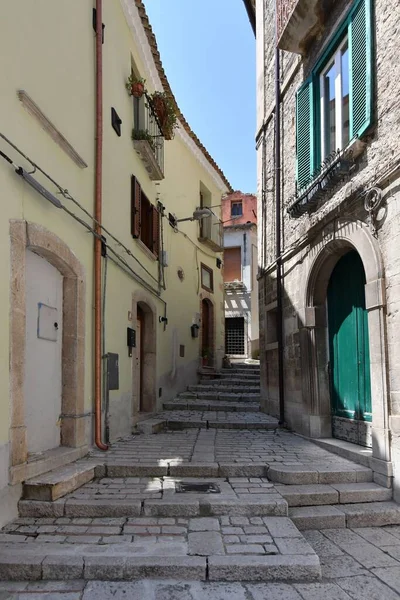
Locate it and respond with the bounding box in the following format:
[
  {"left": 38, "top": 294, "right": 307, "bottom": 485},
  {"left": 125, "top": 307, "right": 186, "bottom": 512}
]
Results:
[{"left": 300, "top": 219, "right": 391, "bottom": 466}]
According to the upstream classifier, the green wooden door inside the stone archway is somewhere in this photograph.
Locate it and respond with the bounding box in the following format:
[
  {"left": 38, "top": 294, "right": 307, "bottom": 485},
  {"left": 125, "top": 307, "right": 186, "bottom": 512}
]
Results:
[{"left": 328, "top": 252, "right": 372, "bottom": 446}]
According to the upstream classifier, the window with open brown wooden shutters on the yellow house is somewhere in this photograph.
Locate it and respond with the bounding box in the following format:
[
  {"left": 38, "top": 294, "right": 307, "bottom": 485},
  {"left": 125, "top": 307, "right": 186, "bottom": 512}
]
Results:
[{"left": 131, "top": 175, "right": 160, "bottom": 258}]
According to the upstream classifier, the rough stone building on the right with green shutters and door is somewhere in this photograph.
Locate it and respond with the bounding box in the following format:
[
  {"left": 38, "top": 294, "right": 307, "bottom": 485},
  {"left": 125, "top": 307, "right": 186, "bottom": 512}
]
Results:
[{"left": 245, "top": 0, "right": 400, "bottom": 498}]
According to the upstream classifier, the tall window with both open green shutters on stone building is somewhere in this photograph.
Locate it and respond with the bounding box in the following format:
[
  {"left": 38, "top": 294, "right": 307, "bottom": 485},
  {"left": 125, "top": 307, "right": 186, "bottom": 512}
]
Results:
[{"left": 296, "top": 0, "right": 373, "bottom": 190}]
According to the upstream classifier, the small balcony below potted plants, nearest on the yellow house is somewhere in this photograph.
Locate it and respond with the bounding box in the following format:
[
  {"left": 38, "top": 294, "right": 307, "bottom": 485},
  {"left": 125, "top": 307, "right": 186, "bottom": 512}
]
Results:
[{"left": 132, "top": 95, "right": 164, "bottom": 181}]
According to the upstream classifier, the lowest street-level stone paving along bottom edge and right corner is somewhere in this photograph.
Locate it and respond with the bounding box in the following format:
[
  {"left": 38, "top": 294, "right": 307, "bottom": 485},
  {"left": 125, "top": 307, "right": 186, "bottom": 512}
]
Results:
[{"left": 0, "top": 518, "right": 400, "bottom": 600}]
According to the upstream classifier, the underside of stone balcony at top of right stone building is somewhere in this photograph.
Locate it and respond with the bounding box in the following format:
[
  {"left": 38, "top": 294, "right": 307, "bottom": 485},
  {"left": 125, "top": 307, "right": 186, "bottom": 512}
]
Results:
[{"left": 276, "top": 0, "right": 334, "bottom": 54}]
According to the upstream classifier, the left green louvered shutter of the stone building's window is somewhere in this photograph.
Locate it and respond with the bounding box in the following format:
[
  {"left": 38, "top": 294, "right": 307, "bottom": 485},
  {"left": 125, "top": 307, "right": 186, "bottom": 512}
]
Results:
[{"left": 296, "top": 79, "right": 314, "bottom": 189}]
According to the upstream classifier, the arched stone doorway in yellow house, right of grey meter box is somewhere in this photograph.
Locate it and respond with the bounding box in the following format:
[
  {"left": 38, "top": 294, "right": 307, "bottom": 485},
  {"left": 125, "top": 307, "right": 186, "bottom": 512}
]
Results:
[{"left": 133, "top": 291, "right": 157, "bottom": 418}]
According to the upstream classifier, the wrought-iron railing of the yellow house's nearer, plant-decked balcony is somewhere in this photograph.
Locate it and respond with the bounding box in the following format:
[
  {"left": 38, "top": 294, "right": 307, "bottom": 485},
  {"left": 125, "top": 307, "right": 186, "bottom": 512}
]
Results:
[{"left": 133, "top": 93, "right": 164, "bottom": 172}]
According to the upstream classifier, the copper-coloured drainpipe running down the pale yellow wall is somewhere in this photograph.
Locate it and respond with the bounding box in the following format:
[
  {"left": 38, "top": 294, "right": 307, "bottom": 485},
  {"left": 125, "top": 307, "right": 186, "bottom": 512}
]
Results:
[{"left": 94, "top": 0, "right": 108, "bottom": 450}]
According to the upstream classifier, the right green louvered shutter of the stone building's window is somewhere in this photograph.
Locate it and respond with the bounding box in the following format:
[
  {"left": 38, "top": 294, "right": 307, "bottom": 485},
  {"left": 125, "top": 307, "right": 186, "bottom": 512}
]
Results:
[{"left": 349, "top": 0, "right": 373, "bottom": 139}]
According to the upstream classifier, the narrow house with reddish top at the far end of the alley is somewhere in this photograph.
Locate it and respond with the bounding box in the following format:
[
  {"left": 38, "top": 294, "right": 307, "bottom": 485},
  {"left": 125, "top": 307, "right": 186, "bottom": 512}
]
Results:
[{"left": 222, "top": 192, "right": 258, "bottom": 358}]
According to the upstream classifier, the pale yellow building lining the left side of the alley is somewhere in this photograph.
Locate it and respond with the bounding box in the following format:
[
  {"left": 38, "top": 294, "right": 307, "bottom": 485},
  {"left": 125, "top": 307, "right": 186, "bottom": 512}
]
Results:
[{"left": 0, "top": 0, "right": 231, "bottom": 524}]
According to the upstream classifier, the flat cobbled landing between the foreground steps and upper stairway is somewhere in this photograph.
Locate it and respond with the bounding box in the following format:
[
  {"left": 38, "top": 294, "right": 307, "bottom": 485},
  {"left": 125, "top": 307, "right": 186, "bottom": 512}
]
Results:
[{"left": 87, "top": 428, "right": 372, "bottom": 470}]
